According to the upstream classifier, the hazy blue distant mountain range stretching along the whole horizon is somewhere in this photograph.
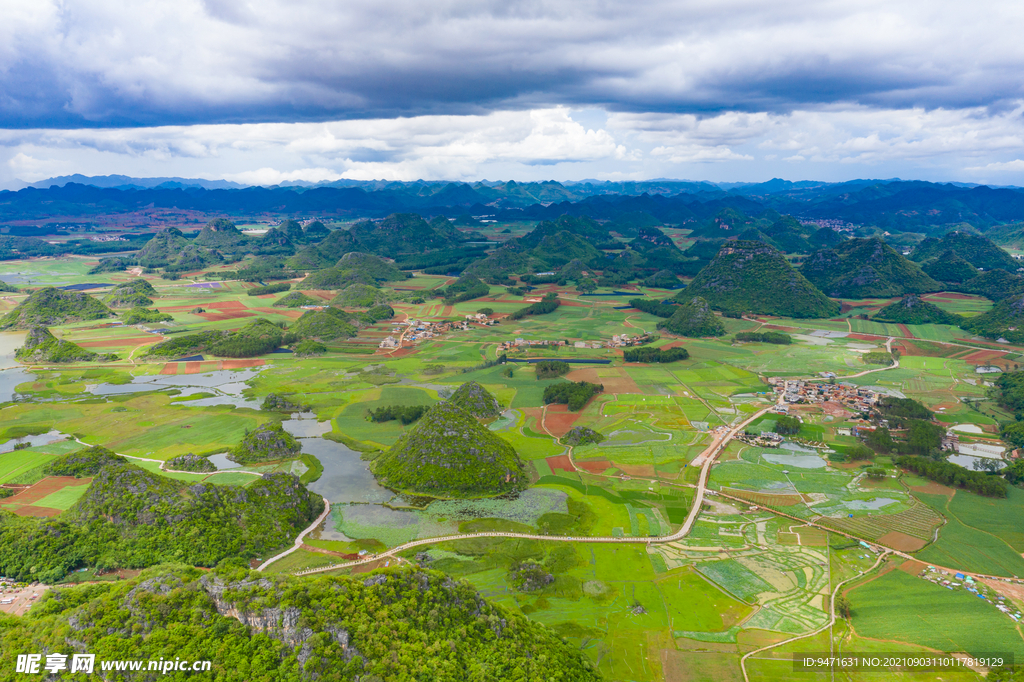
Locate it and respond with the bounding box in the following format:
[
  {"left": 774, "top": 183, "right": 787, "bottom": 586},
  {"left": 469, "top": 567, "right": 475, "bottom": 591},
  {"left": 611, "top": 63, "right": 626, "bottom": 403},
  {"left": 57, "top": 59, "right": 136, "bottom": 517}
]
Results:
[{"left": 0, "top": 175, "right": 1024, "bottom": 232}]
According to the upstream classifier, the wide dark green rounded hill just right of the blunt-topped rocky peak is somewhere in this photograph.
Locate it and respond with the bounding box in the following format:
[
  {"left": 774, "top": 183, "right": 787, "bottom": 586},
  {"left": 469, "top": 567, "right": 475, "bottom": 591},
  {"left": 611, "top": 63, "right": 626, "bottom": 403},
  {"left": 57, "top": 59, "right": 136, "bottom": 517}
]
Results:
[{"left": 800, "top": 238, "right": 942, "bottom": 298}]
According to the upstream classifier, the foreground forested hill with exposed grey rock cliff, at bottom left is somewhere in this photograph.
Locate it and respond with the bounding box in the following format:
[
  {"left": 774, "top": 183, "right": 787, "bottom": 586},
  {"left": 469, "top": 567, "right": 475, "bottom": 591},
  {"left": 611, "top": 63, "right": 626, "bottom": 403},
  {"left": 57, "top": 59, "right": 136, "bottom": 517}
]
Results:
[{"left": 0, "top": 562, "right": 600, "bottom": 682}]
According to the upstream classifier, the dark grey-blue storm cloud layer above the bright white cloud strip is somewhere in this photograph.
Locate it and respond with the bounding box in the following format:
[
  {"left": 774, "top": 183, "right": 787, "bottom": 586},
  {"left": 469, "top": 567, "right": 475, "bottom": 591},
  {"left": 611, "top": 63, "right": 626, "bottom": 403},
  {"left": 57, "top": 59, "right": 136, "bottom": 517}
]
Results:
[{"left": 0, "top": 0, "right": 1024, "bottom": 128}]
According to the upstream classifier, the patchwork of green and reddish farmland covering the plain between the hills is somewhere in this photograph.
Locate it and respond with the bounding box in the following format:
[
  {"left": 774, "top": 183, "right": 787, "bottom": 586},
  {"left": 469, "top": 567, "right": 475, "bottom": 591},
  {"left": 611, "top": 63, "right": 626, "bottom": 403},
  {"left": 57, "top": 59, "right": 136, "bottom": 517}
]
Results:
[{"left": 0, "top": 254, "right": 1024, "bottom": 682}]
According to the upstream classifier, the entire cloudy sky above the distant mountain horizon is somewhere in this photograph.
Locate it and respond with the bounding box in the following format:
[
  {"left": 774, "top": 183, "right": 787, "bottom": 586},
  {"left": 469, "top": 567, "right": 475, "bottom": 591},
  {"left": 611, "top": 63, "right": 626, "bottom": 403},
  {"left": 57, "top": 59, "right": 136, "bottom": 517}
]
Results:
[{"left": 0, "top": 0, "right": 1024, "bottom": 187}]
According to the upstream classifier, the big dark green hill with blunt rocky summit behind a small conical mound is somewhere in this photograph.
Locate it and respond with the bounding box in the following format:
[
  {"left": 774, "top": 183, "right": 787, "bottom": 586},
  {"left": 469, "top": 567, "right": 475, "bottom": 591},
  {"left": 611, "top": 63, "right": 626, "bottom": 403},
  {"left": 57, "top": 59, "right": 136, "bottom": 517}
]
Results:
[{"left": 676, "top": 241, "right": 840, "bottom": 317}]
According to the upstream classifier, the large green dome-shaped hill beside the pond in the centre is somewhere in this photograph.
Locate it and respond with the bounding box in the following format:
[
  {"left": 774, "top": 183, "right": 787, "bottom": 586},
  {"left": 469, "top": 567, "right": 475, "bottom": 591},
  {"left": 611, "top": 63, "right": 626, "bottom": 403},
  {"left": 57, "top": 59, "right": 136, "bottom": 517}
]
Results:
[{"left": 370, "top": 402, "right": 528, "bottom": 498}]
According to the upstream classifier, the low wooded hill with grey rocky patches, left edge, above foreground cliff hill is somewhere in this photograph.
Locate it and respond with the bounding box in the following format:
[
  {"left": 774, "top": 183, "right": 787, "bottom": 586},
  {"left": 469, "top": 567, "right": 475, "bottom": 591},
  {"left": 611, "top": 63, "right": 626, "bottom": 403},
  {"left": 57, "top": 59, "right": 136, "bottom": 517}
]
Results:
[{"left": 0, "top": 447, "right": 324, "bottom": 583}]
